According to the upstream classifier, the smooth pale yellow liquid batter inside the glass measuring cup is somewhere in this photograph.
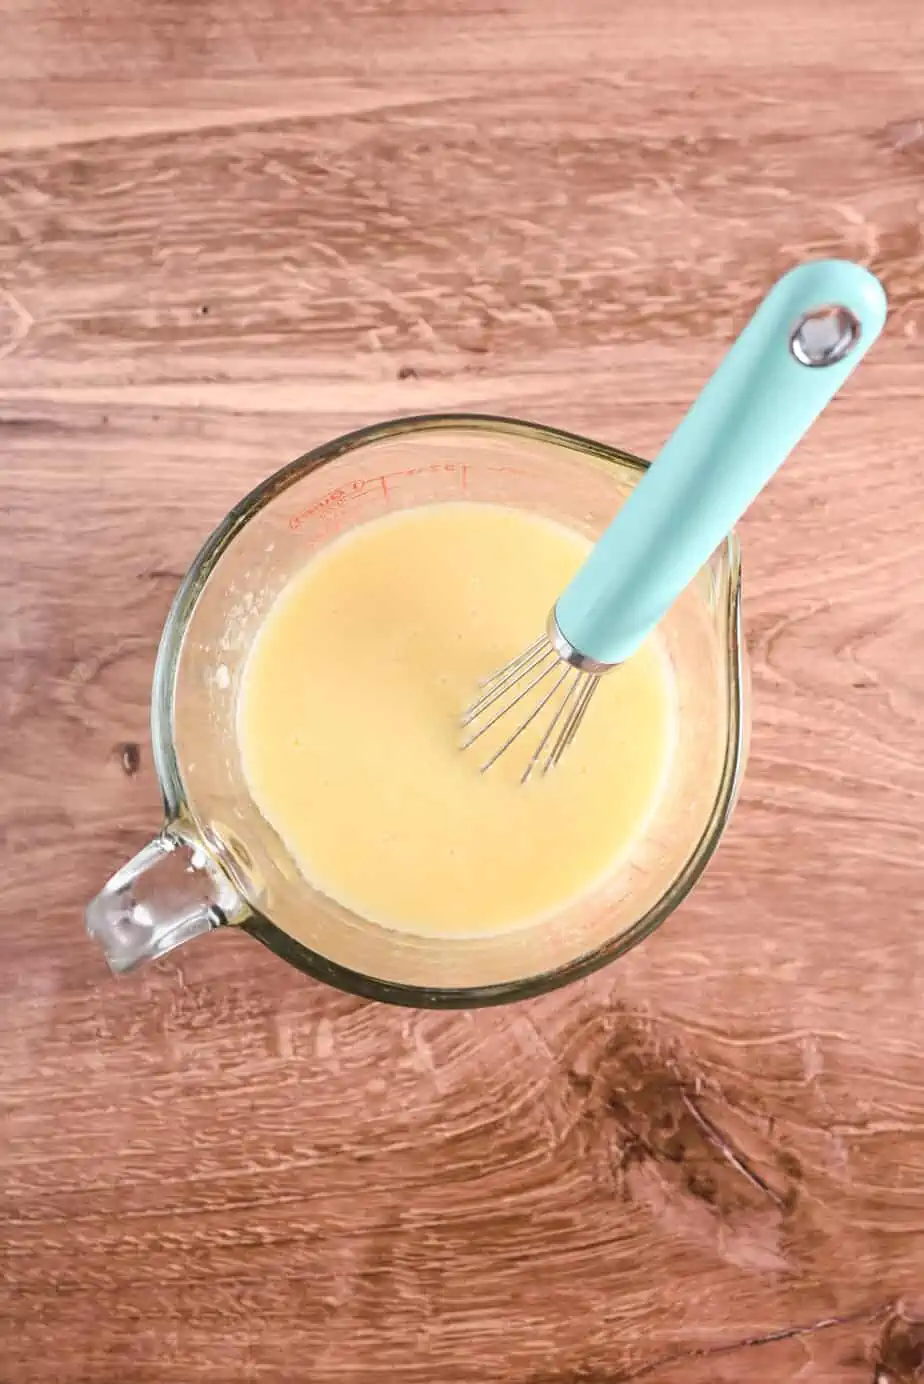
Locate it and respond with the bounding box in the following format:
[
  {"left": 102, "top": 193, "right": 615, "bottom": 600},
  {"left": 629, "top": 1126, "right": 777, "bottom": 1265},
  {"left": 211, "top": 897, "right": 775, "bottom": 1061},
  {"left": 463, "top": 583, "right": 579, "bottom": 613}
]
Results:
[{"left": 238, "top": 502, "right": 674, "bottom": 937}]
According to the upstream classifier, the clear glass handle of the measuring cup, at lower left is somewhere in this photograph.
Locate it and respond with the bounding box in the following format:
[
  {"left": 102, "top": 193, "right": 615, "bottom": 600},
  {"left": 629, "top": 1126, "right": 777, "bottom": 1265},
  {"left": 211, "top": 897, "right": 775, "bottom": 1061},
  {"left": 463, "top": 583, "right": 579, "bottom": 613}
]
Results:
[{"left": 86, "top": 828, "right": 242, "bottom": 974}]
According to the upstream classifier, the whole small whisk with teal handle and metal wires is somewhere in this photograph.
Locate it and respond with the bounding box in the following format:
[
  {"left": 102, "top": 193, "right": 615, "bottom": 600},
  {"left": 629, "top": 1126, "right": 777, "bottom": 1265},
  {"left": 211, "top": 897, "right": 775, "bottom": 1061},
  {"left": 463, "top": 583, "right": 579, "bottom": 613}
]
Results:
[{"left": 462, "top": 260, "right": 887, "bottom": 783}]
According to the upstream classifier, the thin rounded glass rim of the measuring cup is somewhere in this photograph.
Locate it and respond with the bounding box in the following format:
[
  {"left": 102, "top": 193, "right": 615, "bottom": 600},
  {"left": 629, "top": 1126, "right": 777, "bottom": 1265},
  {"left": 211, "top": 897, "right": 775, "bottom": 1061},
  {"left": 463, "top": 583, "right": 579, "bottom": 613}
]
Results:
[{"left": 151, "top": 412, "right": 746, "bottom": 1009}]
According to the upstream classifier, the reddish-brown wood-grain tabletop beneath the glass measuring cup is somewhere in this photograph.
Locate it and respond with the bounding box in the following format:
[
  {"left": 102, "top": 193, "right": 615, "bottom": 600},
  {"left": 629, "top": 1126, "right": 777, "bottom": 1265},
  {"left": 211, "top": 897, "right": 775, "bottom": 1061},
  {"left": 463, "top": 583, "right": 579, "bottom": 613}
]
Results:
[{"left": 0, "top": 0, "right": 924, "bottom": 1384}]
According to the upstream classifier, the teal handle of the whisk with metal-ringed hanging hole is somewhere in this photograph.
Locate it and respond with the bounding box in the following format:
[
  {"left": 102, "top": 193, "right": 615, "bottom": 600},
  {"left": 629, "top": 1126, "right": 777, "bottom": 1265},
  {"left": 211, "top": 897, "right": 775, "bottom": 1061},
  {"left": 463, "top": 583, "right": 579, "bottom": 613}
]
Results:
[{"left": 555, "top": 260, "right": 885, "bottom": 666}]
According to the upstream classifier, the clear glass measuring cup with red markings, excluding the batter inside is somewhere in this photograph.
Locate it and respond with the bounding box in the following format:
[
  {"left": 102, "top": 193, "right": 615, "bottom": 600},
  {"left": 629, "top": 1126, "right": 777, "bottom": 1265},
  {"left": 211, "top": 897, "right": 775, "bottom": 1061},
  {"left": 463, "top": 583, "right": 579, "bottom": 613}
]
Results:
[{"left": 87, "top": 415, "right": 748, "bottom": 1008}]
